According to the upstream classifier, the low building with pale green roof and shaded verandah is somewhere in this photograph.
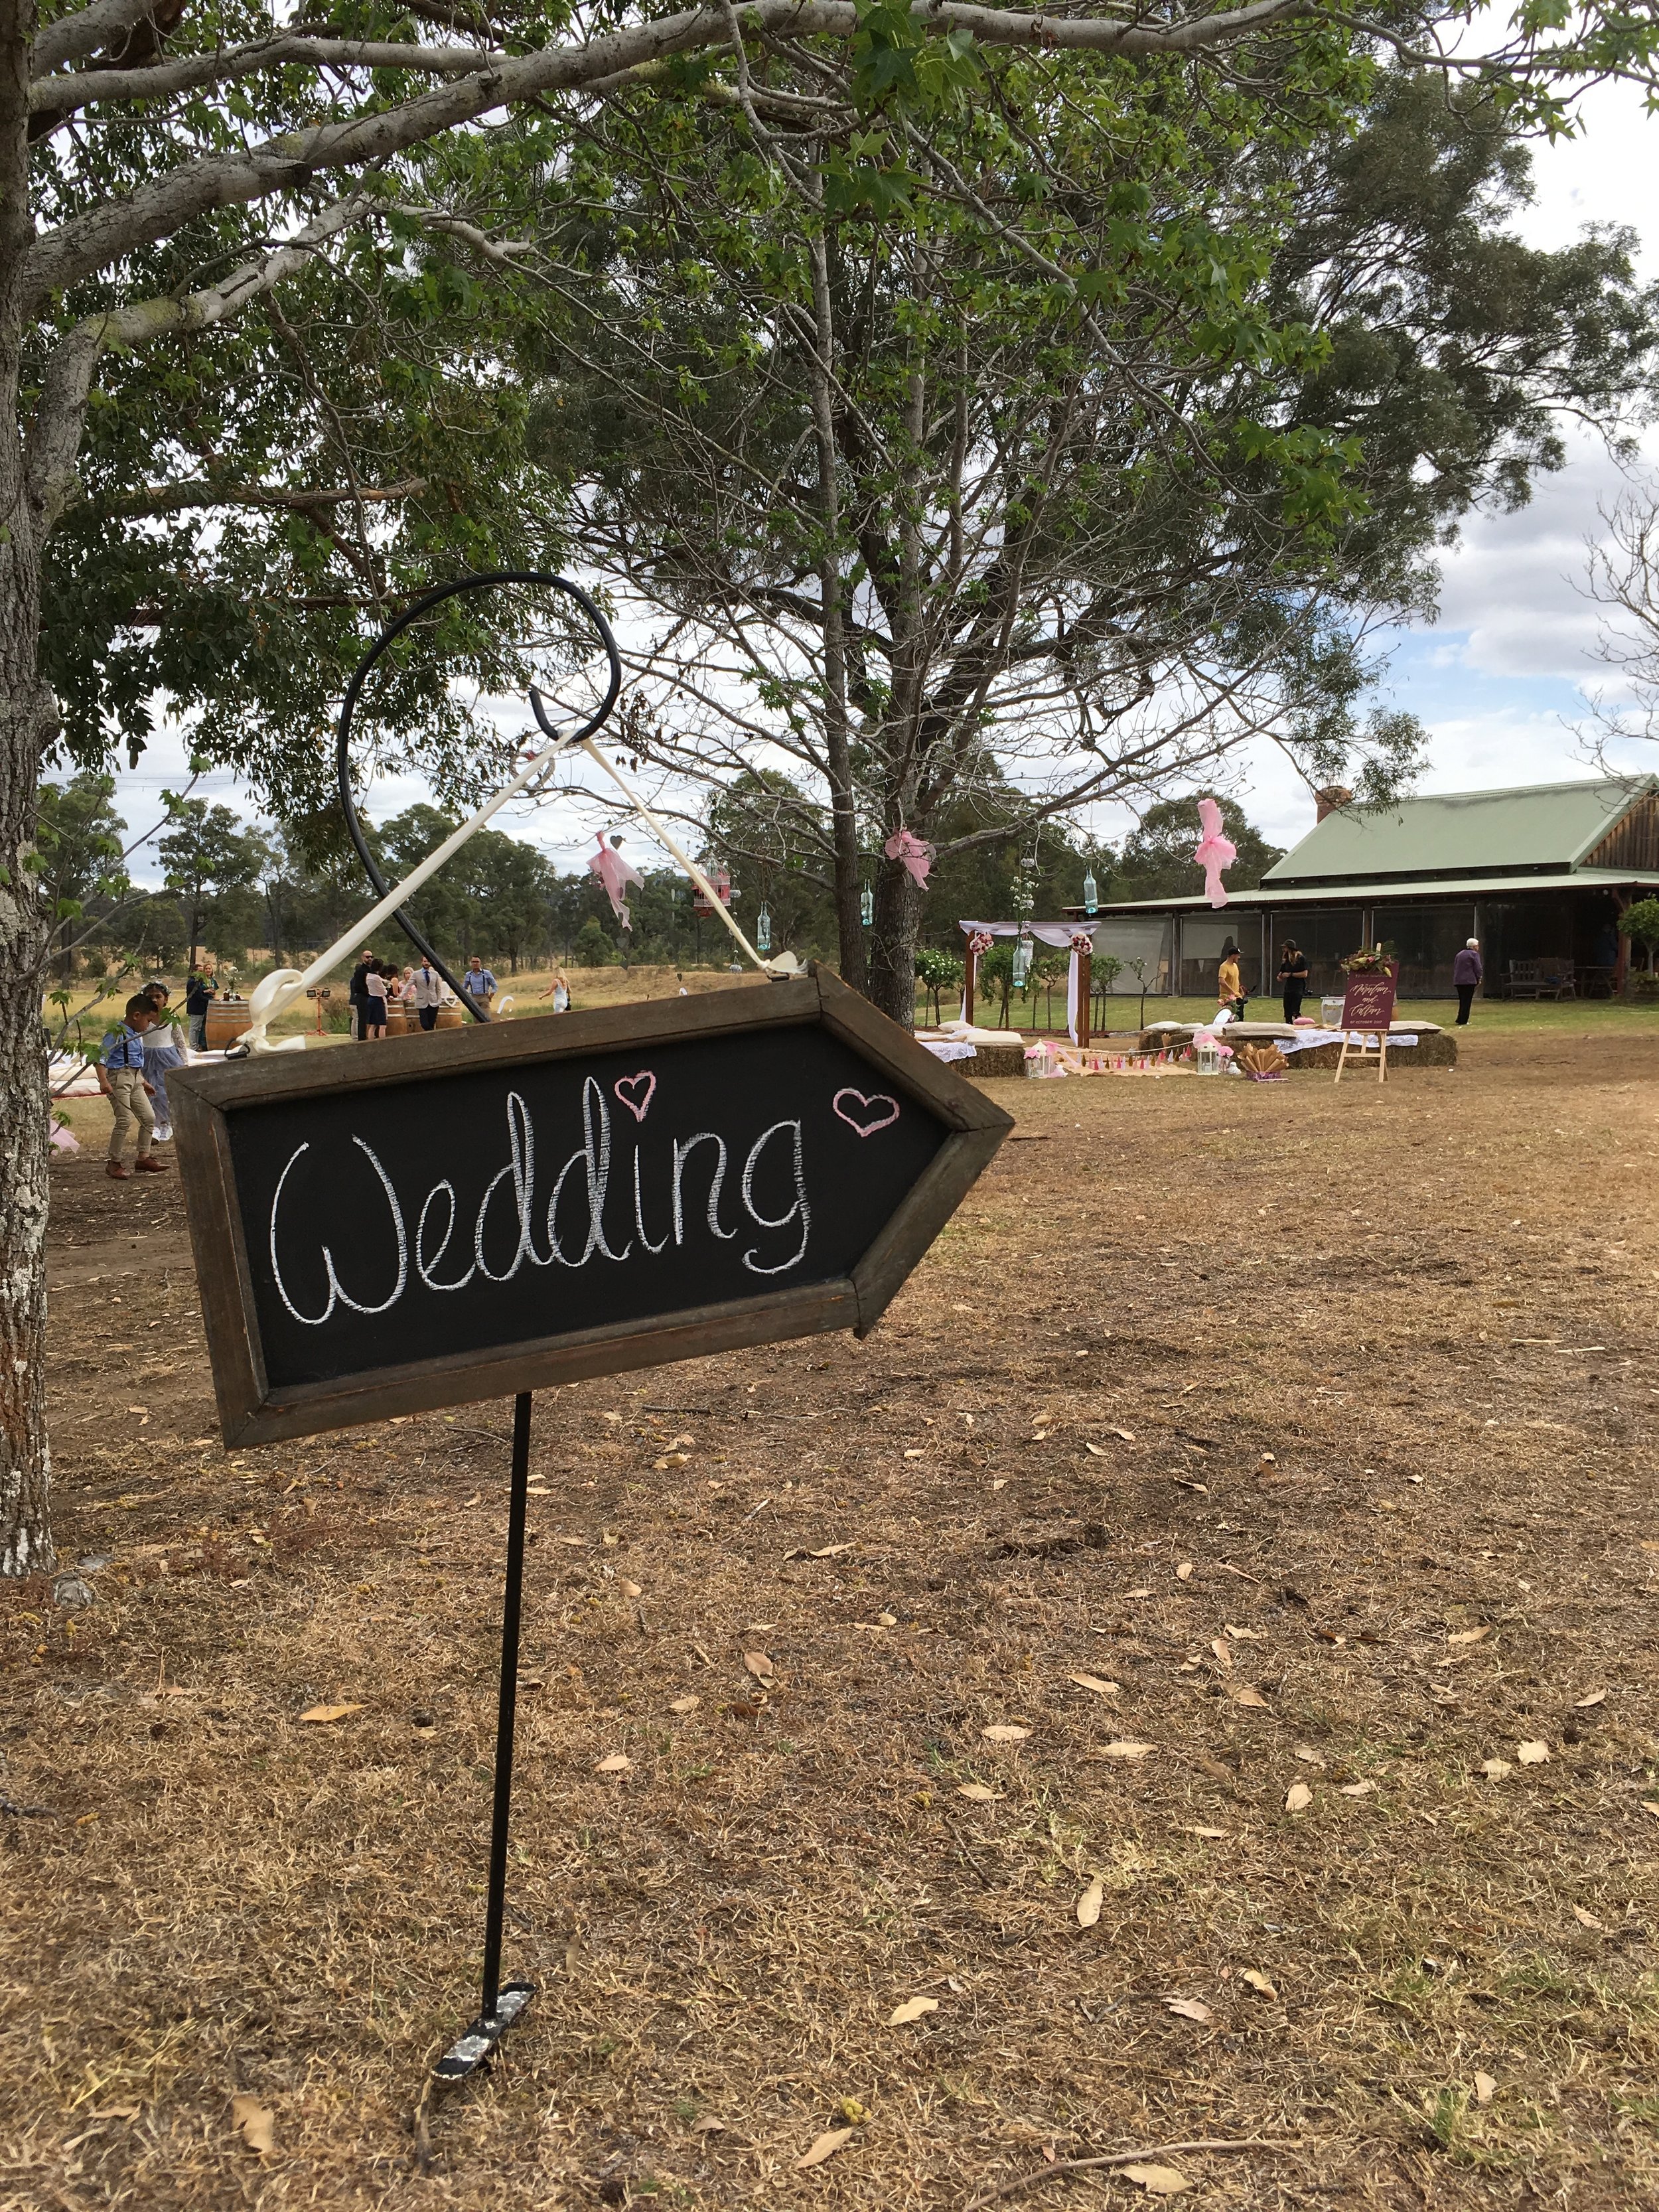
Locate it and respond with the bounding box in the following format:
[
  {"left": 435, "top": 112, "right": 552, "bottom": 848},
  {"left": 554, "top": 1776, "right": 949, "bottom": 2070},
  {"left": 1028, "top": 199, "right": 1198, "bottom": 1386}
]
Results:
[{"left": 1068, "top": 776, "right": 1659, "bottom": 997}]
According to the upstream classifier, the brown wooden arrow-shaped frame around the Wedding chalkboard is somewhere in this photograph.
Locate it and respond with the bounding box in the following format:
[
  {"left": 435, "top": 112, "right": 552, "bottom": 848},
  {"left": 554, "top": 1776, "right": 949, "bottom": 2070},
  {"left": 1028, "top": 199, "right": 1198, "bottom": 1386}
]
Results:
[{"left": 168, "top": 967, "right": 1013, "bottom": 1444}]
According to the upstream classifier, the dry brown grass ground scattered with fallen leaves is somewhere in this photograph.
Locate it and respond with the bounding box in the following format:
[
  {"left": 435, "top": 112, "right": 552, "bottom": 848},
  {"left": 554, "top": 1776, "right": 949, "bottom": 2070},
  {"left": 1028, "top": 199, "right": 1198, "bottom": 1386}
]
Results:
[{"left": 0, "top": 1027, "right": 1659, "bottom": 2212}]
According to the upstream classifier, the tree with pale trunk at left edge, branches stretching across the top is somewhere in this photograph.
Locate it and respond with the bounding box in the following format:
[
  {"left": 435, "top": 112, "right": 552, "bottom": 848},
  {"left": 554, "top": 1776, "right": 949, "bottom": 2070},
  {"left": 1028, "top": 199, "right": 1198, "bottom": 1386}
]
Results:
[{"left": 0, "top": 0, "right": 1654, "bottom": 1573}]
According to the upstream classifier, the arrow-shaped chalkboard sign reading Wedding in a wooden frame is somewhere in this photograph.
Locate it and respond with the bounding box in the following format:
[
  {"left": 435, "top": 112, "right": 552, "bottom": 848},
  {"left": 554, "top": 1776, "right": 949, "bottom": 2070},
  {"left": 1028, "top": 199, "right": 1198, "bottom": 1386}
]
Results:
[{"left": 168, "top": 971, "right": 1011, "bottom": 1442}]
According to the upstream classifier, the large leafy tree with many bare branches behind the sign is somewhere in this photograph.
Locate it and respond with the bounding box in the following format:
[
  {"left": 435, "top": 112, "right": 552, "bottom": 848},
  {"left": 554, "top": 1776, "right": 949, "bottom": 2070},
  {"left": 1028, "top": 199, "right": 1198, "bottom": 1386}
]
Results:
[{"left": 522, "top": 58, "right": 1657, "bottom": 1020}]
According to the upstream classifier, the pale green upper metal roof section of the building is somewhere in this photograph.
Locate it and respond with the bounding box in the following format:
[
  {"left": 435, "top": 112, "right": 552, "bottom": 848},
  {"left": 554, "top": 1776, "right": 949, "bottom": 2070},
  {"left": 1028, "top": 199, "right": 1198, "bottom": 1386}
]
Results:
[{"left": 1263, "top": 776, "right": 1657, "bottom": 896}]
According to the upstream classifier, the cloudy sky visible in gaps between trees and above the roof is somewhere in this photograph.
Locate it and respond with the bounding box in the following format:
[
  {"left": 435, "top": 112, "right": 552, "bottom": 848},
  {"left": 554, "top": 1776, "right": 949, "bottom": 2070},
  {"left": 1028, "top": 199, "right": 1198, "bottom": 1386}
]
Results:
[{"left": 104, "top": 88, "right": 1659, "bottom": 878}]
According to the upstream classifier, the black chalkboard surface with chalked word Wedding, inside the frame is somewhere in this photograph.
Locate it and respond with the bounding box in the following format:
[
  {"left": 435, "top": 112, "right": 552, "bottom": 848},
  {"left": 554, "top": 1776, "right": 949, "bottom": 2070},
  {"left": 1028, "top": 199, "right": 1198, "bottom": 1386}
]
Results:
[{"left": 230, "top": 1029, "right": 944, "bottom": 1384}]
